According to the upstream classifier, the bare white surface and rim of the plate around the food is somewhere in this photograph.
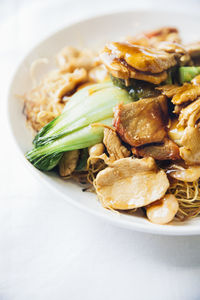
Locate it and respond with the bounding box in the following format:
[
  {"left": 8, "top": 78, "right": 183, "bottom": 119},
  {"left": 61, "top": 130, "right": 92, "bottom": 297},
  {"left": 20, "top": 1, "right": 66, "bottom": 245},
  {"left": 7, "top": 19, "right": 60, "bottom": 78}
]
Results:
[{"left": 8, "top": 11, "right": 200, "bottom": 235}]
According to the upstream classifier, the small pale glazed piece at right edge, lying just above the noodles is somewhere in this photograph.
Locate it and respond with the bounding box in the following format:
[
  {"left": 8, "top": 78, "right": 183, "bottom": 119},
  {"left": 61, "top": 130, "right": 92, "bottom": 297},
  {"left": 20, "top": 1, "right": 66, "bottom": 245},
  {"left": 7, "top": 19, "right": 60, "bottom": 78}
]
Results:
[{"left": 167, "top": 164, "right": 200, "bottom": 182}]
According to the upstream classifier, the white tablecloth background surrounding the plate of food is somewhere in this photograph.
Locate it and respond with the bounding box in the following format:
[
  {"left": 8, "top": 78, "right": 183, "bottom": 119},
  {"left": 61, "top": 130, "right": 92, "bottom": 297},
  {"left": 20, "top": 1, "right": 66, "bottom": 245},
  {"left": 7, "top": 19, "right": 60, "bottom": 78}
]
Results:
[{"left": 0, "top": 0, "right": 200, "bottom": 300}]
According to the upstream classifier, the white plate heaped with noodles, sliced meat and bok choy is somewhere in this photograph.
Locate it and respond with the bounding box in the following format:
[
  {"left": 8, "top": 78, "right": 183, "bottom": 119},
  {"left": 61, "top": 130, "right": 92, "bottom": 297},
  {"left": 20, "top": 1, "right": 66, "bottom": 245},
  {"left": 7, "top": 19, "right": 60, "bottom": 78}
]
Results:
[{"left": 8, "top": 11, "right": 200, "bottom": 235}]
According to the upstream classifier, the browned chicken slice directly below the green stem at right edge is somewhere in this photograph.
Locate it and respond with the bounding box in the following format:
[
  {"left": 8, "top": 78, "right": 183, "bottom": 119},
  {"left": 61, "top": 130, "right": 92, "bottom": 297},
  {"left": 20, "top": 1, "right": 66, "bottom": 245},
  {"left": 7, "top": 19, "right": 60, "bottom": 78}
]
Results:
[{"left": 157, "top": 75, "right": 200, "bottom": 105}]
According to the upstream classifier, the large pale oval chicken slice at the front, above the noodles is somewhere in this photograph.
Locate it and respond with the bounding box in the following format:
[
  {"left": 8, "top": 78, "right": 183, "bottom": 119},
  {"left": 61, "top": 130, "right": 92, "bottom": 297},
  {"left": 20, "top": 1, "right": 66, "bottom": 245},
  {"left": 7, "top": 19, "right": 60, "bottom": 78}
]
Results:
[{"left": 95, "top": 157, "right": 169, "bottom": 210}]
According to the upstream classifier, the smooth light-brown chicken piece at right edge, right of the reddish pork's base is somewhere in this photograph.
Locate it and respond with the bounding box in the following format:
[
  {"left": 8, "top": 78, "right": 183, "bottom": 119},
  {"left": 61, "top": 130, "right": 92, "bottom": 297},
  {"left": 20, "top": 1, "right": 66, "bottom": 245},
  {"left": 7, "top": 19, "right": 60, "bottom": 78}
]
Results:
[{"left": 180, "top": 127, "right": 200, "bottom": 165}]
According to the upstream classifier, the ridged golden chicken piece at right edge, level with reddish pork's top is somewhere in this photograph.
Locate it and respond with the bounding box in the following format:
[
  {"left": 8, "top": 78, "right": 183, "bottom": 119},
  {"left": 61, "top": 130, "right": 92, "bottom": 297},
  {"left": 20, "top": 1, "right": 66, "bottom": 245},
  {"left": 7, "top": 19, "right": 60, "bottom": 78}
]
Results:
[{"left": 177, "top": 98, "right": 200, "bottom": 127}]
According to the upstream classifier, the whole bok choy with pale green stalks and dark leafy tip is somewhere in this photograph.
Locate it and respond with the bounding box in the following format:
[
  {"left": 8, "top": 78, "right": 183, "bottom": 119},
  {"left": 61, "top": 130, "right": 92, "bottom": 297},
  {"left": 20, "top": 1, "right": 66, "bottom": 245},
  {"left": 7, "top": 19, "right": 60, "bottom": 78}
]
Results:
[{"left": 26, "top": 82, "right": 132, "bottom": 171}]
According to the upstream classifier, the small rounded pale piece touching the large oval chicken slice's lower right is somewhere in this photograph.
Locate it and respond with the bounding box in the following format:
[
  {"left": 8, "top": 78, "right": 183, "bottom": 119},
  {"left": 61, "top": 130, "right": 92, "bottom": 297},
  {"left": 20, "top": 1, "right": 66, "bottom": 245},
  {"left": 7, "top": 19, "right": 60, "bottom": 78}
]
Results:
[{"left": 146, "top": 194, "right": 179, "bottom": 225}]
